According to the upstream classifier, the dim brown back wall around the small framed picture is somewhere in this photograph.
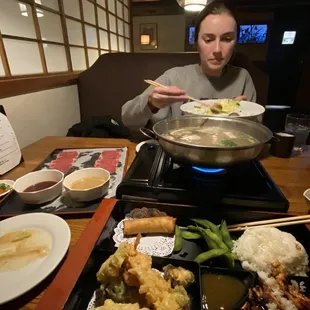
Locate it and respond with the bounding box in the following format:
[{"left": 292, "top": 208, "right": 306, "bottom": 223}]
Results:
[{"left": 133, "top": 15, "right": 185, "bottom": 53}]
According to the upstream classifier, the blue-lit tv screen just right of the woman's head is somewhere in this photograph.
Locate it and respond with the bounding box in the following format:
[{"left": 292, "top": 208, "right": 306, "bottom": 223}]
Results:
[{"left": 238, "top": 25, "right": 268, "bottom": 44}]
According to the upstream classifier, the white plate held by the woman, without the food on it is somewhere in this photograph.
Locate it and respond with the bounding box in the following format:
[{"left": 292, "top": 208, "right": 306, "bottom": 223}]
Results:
[{"left": 181, "top": 99, "right": 265, "bottom": 119}]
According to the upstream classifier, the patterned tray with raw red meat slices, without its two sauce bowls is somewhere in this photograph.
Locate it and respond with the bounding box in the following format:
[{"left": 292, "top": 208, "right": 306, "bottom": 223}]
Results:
[{"left": 0, "top": 147, "right": 127, "bottom": 217}]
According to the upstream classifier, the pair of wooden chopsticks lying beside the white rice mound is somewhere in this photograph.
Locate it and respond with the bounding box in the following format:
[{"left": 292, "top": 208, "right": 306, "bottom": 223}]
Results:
[{"left": 228, "top": 215, "right": 310, "bottom": 231}]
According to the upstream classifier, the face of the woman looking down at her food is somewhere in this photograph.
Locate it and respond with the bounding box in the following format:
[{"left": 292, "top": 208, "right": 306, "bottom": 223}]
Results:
[{"left": 197, "top": 13, "right": 237, "bottom": 76}]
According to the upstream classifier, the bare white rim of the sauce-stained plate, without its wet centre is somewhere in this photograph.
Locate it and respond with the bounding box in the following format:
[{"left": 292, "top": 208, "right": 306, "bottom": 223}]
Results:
[{"left": 0, "top": 213, "right": 71, "bottom": 304}]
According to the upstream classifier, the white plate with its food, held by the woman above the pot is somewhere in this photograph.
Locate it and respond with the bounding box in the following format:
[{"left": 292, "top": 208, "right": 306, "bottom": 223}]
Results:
[{"left": 181, "top": 99, "right": 265, "bottom": 119}]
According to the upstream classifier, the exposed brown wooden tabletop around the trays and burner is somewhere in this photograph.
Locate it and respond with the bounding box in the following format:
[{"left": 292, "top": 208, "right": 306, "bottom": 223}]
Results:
[{"left": 0, "top": 137, "right": 310, "bottom": 310}]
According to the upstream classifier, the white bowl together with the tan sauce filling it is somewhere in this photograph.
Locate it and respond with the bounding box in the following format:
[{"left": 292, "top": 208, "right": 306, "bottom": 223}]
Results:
[{"left": 63, "top": 168, "right": 110, "bottom": 201}]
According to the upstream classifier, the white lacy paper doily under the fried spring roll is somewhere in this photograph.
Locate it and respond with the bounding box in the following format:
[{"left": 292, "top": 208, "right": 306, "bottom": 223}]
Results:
[{"left": 113, "top": 217, "right": 175, "bottom": 257}]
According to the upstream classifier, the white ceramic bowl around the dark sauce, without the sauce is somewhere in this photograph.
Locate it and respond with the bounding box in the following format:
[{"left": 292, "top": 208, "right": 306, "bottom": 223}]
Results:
[{"left": 13, "top": 170, "right": 64, "bottom": 204}]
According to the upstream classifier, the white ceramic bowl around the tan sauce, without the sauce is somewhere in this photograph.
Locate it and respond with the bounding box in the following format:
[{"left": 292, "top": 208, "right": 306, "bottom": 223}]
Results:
[{"left": 63, "top": 168, "right": 110, "bottom": 201}]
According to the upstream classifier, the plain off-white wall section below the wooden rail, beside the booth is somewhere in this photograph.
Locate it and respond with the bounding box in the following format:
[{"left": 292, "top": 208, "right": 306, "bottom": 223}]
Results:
[{"left": 0, "top": 85, "right": 80, "bottom": 148}]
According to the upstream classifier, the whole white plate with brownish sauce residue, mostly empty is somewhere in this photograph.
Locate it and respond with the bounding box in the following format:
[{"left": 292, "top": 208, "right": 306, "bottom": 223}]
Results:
[{"left": 0, "top": 213, "right": 71, "bottom": 304}]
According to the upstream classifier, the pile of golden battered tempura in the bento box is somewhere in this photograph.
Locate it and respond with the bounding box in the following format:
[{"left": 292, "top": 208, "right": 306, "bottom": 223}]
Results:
[{"left": 95, "top": 237, "right": 193, "bottom": 310}]
